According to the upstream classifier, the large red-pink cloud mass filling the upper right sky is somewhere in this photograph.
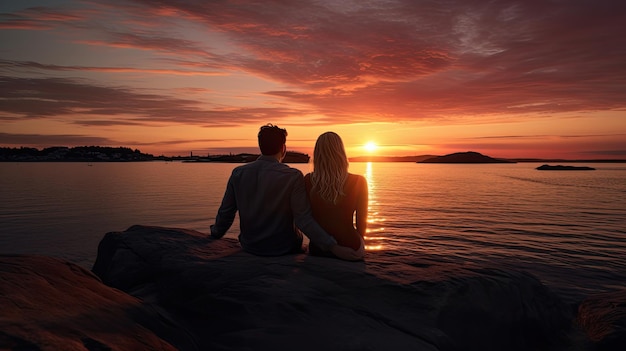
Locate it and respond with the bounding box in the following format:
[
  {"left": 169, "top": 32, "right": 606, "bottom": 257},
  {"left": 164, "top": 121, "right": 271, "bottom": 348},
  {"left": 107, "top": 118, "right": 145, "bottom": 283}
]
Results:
[{"left": 113, "top": 0, "right": 626, "bottom": 122}]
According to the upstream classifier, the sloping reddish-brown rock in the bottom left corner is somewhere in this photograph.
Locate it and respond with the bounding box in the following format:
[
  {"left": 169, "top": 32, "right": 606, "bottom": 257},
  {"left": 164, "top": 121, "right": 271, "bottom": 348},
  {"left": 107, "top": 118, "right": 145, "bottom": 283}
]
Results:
[{"left": 0, "top": 255, "right": 193, "bottom": 351}]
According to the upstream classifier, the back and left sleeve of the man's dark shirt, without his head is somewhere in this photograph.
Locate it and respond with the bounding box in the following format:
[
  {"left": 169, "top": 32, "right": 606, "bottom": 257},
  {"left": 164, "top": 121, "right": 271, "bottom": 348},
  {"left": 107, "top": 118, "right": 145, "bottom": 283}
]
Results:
[{"left": 212, "top": 156, "right": 310, "bottom": 255}]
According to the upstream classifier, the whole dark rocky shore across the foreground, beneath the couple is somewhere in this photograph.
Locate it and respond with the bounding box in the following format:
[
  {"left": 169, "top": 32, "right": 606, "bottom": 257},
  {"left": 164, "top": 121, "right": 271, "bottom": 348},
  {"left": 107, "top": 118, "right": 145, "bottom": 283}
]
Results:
[{"left": 0, "top": 226, "right": 626, "bottom": 351}]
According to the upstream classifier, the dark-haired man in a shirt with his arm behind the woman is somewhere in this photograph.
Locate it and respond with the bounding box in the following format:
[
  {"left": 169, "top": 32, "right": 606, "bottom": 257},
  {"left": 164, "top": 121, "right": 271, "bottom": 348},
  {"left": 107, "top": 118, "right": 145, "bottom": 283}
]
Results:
[{"left": 211, "top": 124, "right": 363, "bottom": 260}]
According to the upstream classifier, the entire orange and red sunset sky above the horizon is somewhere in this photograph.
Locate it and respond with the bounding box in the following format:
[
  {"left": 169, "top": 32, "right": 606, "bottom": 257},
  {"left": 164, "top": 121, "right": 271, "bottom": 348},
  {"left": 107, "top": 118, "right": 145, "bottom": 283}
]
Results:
[{"left": 0, "top": 0, "right": 626, "bottom": 159}]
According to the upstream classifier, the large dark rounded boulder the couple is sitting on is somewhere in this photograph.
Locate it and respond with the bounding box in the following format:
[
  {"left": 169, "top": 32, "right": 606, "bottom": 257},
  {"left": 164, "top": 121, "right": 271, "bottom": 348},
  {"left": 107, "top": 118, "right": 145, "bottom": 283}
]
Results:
[{"left": 93, "top": 226, "right": 575, "bottom": 351}]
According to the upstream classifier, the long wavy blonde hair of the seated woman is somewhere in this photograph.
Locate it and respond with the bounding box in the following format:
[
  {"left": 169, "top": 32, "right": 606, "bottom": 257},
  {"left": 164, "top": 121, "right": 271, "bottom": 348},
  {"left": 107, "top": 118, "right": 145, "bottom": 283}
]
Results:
[{"left": 311, "top": 132, "right": 348, "bottom": 204}]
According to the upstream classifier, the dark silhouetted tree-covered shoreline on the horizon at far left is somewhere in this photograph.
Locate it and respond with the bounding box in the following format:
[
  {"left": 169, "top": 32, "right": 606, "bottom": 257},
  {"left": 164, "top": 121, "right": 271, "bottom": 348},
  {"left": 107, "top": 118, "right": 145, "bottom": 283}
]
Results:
[{"left": 0, "top": 146, "right": 154, "bottom": 162}]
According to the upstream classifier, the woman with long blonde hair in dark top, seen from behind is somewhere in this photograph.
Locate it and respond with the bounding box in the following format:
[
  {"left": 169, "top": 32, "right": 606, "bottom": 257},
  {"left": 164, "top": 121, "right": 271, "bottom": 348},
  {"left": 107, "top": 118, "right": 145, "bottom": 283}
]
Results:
[{"left": 304, "top": 132, "right": 368, "bottom": 258}]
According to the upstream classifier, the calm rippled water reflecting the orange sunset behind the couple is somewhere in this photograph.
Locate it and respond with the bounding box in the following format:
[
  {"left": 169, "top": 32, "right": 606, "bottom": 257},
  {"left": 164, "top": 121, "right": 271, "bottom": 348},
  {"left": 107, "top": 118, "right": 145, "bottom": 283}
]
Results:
[{"left": 0, "top": 162, "right": 626, "bottom": 297}]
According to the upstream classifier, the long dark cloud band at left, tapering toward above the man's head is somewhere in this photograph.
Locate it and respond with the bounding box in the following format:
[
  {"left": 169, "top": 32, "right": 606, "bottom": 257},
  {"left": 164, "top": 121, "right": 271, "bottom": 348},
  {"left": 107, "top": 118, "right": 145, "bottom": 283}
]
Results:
[{"left": 0, "top": 77, "right": 302, "bottom": 127}]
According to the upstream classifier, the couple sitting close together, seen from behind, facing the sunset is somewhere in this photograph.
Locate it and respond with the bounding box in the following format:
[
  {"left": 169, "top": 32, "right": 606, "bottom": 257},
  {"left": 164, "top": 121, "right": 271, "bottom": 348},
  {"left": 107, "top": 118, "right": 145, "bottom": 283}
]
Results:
[{"left": 211, "top": 124, "right": 368, "bottom": 261}]
